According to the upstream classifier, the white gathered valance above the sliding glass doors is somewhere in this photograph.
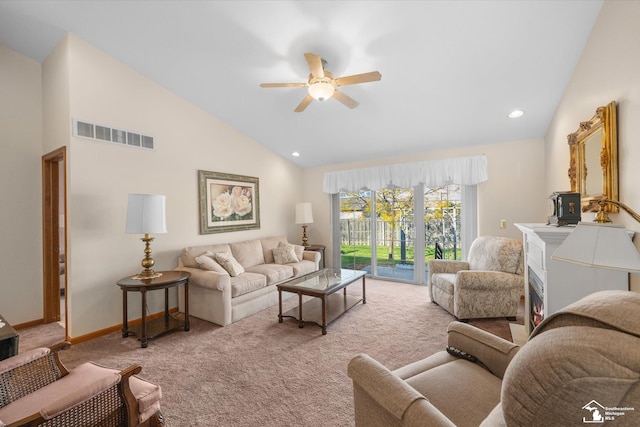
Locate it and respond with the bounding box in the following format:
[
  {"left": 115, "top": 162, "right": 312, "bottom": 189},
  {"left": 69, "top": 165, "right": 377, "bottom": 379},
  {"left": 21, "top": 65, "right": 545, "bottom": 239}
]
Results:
[{"left": 323, "top": 155, "right": 489, "bottom": 194}]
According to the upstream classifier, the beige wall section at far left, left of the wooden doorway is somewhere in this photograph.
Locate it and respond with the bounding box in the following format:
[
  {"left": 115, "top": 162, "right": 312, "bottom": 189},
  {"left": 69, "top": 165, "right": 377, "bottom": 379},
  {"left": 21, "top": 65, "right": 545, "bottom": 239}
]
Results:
[{"left": 0, "top": 45, "right": 42, "bottom": 324}]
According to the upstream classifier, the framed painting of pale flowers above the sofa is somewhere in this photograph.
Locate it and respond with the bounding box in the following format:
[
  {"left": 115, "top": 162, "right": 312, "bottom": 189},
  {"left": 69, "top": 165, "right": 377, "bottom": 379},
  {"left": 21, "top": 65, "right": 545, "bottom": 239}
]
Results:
[{"left": 198, "top": 171, "right": 260, "bottom": 234}]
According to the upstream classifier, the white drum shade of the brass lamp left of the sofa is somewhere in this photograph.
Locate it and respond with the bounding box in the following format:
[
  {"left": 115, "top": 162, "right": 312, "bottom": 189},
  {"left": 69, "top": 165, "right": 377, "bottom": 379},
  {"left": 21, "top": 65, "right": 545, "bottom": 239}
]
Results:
[{"left": 125, "top": 194, "right": 167, "bottom": 234}]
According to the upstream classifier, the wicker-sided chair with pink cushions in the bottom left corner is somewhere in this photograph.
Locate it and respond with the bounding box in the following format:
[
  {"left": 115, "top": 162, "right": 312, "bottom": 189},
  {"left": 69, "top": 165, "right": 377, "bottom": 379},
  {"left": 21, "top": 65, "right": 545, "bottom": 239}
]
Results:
[{"left": 0, "top": 342, "right": 164, "bottom": 427}]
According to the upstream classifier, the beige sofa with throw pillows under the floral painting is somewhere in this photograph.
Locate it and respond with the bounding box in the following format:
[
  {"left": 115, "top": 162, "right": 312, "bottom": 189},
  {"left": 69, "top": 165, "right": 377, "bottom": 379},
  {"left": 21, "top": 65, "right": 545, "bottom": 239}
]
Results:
[{"left": 176, "top": 236, "right": 321, "bottom": 326}]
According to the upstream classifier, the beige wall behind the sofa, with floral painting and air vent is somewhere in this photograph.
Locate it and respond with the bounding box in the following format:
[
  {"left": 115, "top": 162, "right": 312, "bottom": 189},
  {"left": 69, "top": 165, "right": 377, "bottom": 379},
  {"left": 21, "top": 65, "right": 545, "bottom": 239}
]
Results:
[{"left": 44, "top": 35, "right": 302, "bottom": 338}]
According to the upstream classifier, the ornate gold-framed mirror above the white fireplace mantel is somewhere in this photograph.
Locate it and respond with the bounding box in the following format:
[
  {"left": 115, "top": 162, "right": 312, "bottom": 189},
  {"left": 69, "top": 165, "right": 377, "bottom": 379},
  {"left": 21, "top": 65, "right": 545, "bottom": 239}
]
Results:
[{"left": 567, "top": 101, "right": 618, "bottom": 212}]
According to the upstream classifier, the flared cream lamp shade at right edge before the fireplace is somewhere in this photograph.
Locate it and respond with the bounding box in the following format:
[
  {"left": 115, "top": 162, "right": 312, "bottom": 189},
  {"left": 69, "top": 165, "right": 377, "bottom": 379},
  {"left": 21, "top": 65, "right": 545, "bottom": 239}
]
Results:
[{"left": 552, "top": 222, "right": 640, "bottom": 273}]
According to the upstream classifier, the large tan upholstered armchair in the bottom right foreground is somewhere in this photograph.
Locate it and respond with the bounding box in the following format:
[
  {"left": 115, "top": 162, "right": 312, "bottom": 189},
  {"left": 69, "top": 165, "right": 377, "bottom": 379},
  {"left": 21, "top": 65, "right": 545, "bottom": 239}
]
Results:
[{"left": 348, "top": 290, "right": 640, "bottom": 427}]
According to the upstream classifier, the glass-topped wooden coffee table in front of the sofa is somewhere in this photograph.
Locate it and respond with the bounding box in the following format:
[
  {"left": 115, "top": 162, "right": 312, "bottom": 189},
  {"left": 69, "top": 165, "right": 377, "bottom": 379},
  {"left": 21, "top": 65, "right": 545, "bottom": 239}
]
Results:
[{"left": 276, "top": 268, "right": 367, "bottom": 335}]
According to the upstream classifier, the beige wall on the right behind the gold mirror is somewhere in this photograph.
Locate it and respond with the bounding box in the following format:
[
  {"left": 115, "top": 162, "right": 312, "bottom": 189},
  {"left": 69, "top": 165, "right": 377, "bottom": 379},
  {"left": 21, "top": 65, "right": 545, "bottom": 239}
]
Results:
[{"left": 545, "top": 1, "right": 640, "bottom": 292}]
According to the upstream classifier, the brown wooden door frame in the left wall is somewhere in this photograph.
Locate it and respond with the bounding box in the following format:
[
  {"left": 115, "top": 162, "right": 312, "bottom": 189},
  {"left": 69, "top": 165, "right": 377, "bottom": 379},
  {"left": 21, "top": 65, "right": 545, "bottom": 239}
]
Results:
[{"left": 42, "top": 147, "right": 69, "bottom": 333}]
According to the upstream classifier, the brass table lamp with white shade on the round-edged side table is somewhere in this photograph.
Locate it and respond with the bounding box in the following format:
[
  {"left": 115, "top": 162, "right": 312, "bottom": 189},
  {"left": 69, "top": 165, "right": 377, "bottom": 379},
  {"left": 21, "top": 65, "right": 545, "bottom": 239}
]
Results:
[{"left": 125, "top": 194, "right": 167, "bottom": 280}]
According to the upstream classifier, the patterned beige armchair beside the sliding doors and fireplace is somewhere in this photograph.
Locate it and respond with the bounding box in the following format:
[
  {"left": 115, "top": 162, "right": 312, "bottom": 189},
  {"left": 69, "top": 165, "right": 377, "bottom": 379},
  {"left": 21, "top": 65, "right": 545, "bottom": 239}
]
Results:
[{"left": 427, "top": 236, "right": 524, "bottom": 320}]
